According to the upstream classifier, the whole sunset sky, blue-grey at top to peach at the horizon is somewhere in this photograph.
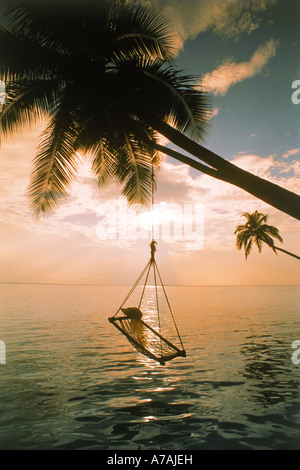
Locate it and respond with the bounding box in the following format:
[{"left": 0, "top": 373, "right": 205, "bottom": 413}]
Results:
[{"left": 0, "top": 0, "right": 300, "bottom": 285}]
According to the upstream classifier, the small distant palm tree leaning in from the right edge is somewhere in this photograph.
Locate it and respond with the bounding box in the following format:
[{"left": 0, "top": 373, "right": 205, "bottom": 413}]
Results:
[{"left": 234, "top": 211, "right": 300, "bottom": 260}]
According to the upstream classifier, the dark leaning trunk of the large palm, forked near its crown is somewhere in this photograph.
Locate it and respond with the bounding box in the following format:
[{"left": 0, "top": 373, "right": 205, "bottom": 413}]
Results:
[{"left": 148, "top": 119, "right": 300, "bottom": 220}]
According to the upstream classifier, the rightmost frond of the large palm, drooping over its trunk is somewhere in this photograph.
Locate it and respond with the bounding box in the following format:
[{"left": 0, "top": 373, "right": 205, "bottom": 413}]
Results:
[{"left": 112, "top": 58, "right": 210, "bottom": 140}]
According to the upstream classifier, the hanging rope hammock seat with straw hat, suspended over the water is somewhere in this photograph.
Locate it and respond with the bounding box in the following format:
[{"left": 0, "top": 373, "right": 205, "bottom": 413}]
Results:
[{"left": 108, "top": 166, "right": 186, "bottom": 365}]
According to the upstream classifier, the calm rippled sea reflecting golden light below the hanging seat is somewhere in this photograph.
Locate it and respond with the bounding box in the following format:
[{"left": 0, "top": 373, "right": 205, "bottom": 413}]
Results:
[{"left": 0, "top": 285, "right": 300, "bottom": 451}]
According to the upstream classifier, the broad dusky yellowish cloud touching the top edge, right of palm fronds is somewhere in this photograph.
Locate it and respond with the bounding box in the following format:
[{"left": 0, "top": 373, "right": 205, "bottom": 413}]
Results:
[{"left": 141, "top": 0, "right": 276, "bottom": 44}]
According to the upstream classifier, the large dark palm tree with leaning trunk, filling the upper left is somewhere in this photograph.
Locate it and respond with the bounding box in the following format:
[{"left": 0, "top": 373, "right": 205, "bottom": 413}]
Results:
[{"left": 0, "top": 0, "right": 300, "bottom": 219}]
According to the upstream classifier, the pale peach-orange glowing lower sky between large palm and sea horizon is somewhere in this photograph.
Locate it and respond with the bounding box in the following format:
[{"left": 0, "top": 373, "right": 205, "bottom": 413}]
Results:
[{"left": 0, "top": 125, "right": 300, "bottom": 285}]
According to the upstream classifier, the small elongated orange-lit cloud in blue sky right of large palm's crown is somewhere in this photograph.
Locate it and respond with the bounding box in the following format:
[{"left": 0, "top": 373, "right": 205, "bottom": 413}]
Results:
[{"left": 201, "top": 39, "right": 279, "bottom": 95}]
